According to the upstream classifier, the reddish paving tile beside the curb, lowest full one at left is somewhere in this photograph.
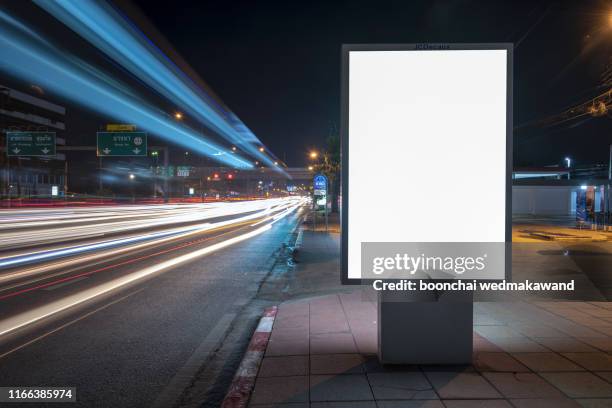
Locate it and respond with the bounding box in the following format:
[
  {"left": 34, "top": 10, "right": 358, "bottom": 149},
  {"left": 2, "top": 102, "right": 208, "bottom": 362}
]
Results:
[{"left": 251, "top": 376, "right": 308, "bottom": 404}]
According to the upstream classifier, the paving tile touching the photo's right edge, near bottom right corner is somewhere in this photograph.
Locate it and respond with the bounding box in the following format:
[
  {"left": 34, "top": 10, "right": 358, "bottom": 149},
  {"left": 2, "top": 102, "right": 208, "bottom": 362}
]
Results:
[{"left": 540, "top": 372, "right": 612, "bottom": 398}]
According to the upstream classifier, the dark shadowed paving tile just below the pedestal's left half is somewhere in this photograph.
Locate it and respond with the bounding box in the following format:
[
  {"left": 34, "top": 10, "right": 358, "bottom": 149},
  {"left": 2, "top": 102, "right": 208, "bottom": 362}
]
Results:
[{"left": 367, "top": 371, "right": 438, "bottom": 400}]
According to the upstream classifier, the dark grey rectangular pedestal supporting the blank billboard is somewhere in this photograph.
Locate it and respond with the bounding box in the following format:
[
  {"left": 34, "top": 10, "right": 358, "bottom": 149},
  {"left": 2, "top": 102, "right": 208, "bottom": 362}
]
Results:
[{"left": 378, "top": 291, "right": 473, "bottom": 364}]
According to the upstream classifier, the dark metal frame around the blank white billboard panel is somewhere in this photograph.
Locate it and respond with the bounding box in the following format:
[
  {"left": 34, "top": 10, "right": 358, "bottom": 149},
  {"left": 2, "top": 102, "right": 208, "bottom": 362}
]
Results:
[{"left": 340, "top": 43, "right": 514, "bottom": 285}]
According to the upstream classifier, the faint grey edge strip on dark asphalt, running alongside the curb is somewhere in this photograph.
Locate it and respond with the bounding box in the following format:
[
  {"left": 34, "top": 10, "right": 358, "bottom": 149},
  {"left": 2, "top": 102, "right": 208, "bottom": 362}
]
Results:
[{"left": 153, "top": 313, "right": 236, "bottom": 408}]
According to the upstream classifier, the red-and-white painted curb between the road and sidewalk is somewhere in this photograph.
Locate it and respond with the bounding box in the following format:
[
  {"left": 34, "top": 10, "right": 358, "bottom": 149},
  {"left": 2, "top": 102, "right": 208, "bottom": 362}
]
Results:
[{"left": 221, "top": 306, "right": 278, "bottom": 408}]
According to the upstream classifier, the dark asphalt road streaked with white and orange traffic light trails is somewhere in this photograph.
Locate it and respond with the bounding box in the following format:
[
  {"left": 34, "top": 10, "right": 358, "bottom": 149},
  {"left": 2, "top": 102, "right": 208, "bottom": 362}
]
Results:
[{"left": 0, "top": 200, "right": 303, "bottom": 407}]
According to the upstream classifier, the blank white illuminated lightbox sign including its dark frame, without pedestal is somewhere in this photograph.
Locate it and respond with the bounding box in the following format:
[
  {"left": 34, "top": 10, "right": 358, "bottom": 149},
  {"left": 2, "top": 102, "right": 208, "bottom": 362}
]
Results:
[{"left": 341, "top": 44, "right": 512, "bottom": 284}]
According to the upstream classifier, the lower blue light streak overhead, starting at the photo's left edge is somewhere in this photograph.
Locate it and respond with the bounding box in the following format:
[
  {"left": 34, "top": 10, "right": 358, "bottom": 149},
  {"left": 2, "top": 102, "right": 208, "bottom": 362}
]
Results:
[{"left": 0, "top": 11, "right": 253, "bottom": 169}]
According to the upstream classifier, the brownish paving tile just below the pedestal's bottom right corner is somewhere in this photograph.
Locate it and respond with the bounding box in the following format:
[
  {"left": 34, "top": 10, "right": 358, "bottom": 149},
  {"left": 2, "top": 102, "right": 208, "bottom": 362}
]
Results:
[{"left": 425, "top": 371, "right": 501, "bottom": 399}]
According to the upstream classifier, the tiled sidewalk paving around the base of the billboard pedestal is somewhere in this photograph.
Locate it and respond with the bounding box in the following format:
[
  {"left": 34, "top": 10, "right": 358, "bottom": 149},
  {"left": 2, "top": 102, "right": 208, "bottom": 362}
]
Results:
[{"left": 249, "top": 291, "right": 612, "bottom": 408}]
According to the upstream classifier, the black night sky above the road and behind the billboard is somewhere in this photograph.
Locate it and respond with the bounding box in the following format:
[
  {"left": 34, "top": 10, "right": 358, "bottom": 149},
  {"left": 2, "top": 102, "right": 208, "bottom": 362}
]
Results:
[{"left": 0, "top": 0, "right": 612, "bottom": 166}]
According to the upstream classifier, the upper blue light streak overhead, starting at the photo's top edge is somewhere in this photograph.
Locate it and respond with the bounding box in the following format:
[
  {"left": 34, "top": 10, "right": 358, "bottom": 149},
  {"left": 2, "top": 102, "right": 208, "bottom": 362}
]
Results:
[{"left": 34, "top": 0, "right": 284, "bottom": 173}]
